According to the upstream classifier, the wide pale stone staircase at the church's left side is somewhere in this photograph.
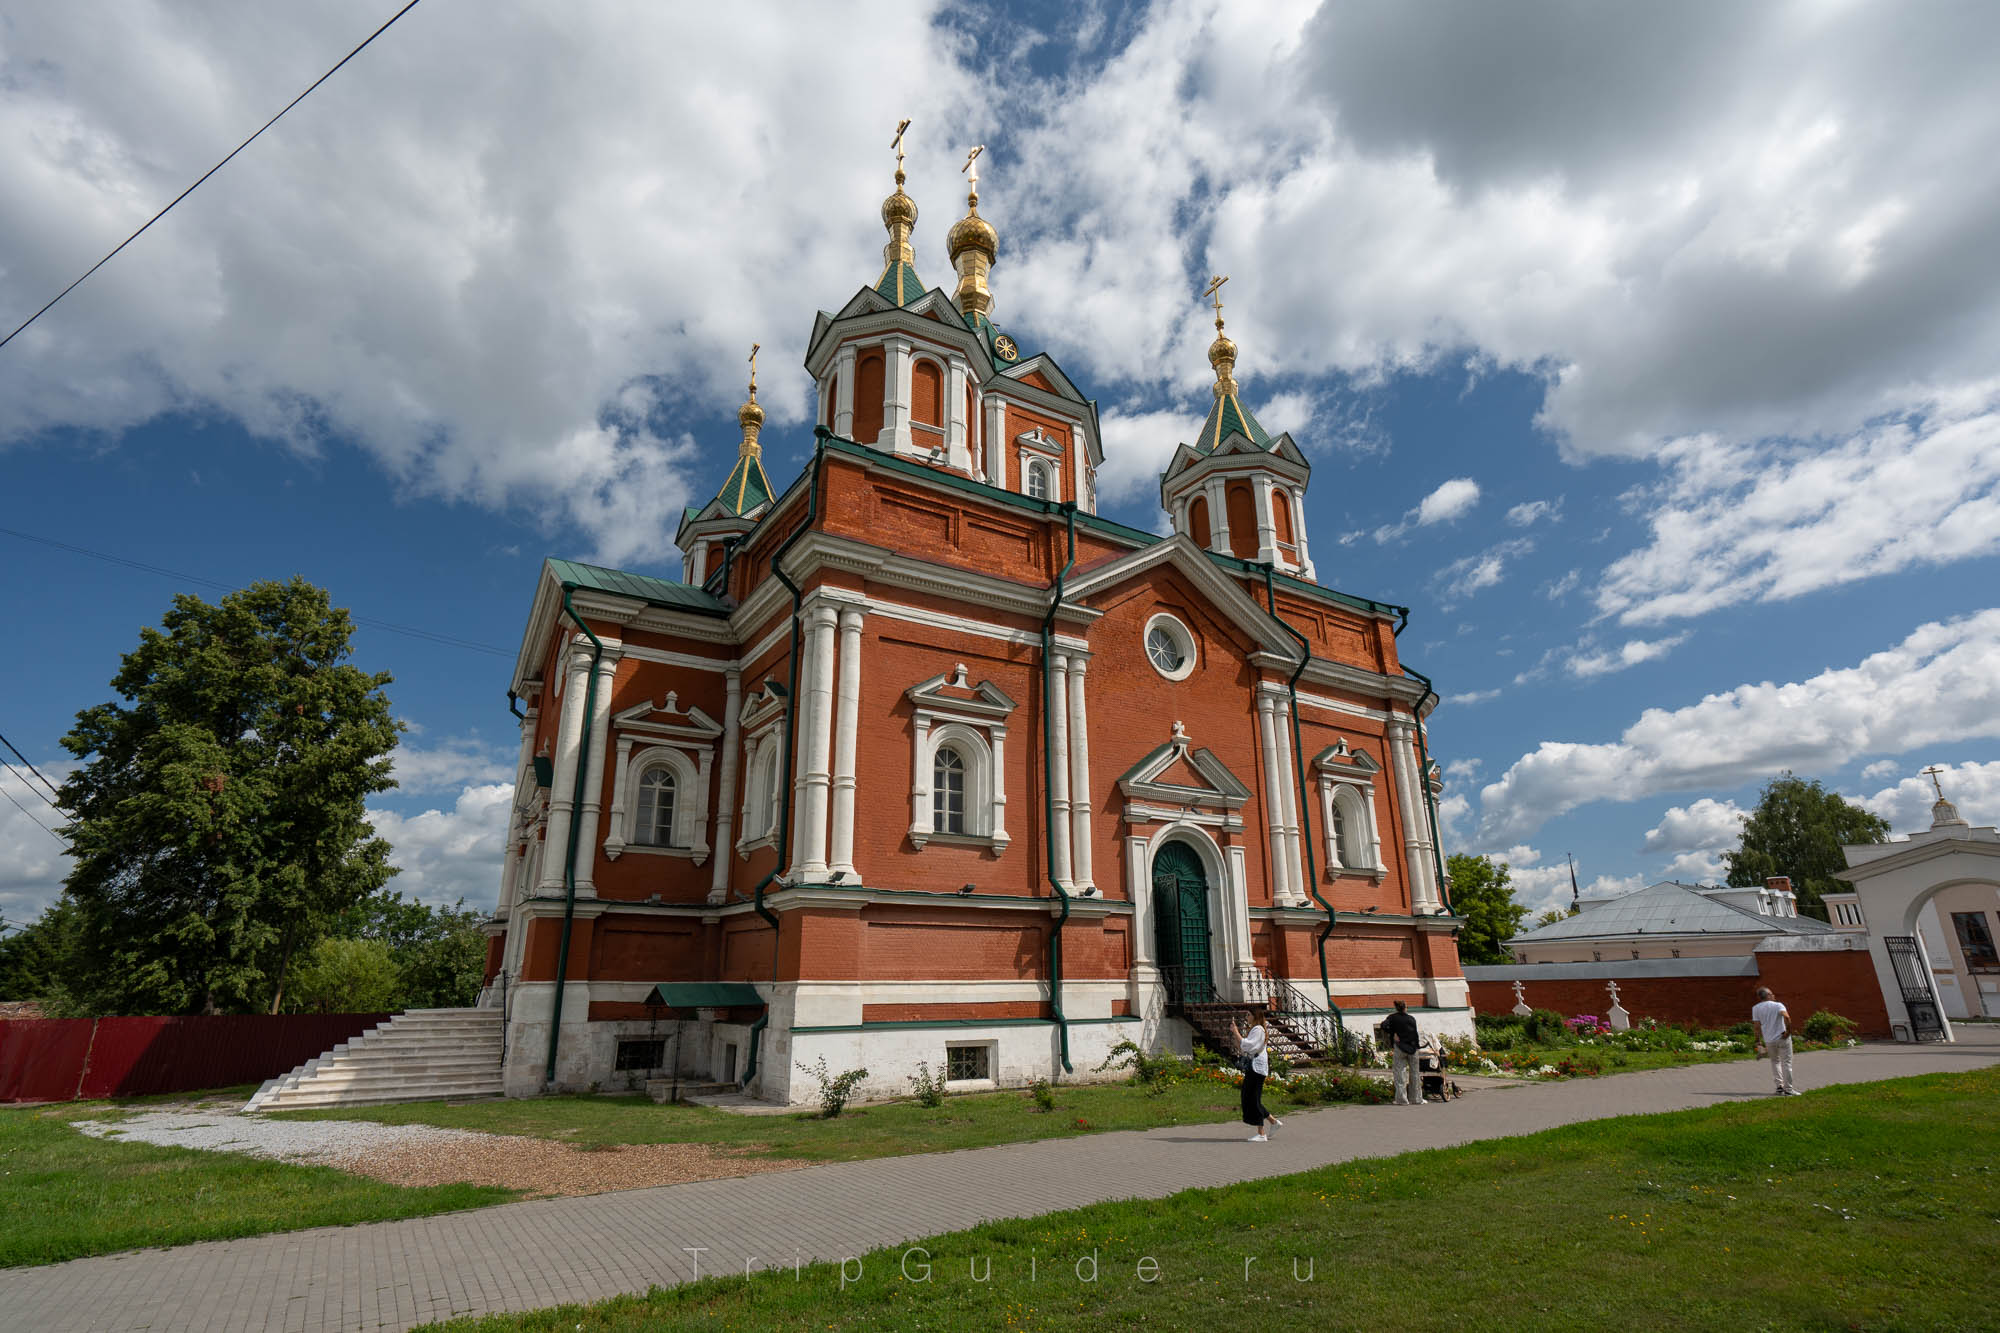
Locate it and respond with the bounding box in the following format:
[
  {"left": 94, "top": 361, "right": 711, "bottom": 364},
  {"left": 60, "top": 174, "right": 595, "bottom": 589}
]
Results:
[{"left": 244, "top": 1009, "right": 506, "bottom": 1111}]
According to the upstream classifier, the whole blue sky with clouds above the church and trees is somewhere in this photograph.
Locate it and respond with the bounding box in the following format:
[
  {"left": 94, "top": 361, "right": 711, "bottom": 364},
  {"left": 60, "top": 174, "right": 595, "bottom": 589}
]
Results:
[{"left": 0, "top": 0, "right": 2000, "bottom": 923}]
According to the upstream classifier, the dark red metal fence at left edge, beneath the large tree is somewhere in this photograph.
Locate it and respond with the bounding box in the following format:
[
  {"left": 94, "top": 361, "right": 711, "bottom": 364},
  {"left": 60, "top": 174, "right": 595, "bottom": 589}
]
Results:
[{"left": 0, "top": 1013, "right": 388, "bottom": 1101}]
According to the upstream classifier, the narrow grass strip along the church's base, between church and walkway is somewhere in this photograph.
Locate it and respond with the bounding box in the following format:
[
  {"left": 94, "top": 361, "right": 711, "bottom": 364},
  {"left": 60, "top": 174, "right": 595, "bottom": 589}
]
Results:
[{"left": 274, "top": 1079, "right": 1264, "bottom": 1161}]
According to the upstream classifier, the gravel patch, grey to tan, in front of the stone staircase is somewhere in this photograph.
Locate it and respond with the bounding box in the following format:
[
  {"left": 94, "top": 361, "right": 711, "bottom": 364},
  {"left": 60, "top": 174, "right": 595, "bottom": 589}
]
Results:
[{"left": 72, "top": 1111, "right": 806, "bottom": 1195}]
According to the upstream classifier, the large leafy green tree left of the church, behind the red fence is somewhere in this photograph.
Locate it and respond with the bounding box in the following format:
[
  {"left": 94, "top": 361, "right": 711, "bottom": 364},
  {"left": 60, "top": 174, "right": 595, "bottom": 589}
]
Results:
[{"left": 62, "top": 578, "right": 400, "bottom": 1013}]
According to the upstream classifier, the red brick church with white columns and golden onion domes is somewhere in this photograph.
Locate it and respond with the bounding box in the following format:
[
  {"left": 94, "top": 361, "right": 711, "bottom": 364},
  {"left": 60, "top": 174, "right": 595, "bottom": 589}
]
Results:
[{"left": 482, "top": 140, "right": 1472, "bottom": 1103}]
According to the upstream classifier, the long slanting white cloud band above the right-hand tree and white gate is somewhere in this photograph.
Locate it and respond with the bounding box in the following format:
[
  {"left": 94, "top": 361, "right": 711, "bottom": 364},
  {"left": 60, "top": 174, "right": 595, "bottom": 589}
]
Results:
[{"left": 1480, "top": 610, "right": 2000, "bottom": 843}]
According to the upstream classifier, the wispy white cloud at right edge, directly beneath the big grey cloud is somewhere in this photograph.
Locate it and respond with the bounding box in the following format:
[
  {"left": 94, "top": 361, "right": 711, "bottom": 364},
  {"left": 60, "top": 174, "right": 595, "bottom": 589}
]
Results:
[{"left": 1596, "top": 380, "right": 2000, "bottom": 624}]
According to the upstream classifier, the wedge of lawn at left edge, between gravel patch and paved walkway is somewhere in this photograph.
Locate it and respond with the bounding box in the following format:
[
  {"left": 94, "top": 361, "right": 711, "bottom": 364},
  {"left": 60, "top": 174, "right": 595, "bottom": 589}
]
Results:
[{"left": 0, "top": 1095, "right": 516, "bottom": 1267}]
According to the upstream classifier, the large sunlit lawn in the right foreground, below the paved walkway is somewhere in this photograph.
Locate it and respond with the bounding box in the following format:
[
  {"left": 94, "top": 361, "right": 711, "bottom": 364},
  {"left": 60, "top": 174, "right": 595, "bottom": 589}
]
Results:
[{"left": 418, "top": 1069, "right": 2000, "bottom": 1333}]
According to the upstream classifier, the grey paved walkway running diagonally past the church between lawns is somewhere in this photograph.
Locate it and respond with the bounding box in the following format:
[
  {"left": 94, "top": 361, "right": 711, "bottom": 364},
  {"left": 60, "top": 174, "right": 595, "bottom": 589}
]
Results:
[{"left": 0, "top": 1027, "right": 2000, "bottom": 1333}]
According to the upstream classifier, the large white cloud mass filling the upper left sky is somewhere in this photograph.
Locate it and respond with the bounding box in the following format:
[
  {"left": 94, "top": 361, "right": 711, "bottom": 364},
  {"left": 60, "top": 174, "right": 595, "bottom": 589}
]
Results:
[{"left": 0, "top": 0, "right": 984, "bottom": 562}]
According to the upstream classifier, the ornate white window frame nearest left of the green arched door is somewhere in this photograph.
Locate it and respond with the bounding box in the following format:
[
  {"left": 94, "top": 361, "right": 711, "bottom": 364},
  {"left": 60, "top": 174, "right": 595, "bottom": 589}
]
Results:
[{"left": 906, "top": 662, "right": 1014, "bottom": 857}]
